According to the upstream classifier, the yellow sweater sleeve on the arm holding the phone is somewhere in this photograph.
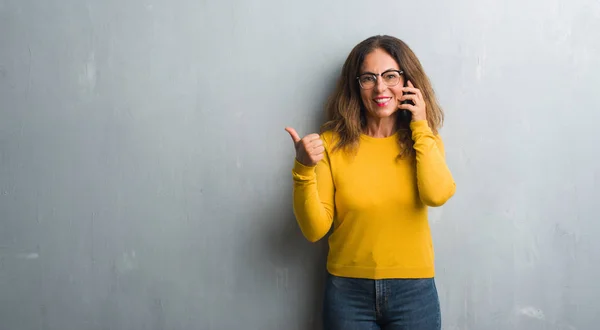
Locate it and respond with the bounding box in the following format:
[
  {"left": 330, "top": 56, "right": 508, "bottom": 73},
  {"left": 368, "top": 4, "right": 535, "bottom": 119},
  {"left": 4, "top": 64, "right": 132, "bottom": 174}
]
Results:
[{"left": 410, "top": 120, "right": 456, "bottom": 206}]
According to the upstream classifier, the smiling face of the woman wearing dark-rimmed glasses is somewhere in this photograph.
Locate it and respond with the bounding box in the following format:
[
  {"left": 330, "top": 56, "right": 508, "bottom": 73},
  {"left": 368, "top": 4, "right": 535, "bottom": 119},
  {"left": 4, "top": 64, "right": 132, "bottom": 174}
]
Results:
[{"left": 359, "top": 48, "right": 404, "bottom": 119}]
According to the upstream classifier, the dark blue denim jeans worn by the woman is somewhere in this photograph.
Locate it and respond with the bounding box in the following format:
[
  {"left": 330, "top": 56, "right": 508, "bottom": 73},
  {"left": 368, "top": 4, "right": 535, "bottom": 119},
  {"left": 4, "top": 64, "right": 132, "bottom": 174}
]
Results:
[{"left": 323, "top": 274, "right": 441, "bottom": 330}]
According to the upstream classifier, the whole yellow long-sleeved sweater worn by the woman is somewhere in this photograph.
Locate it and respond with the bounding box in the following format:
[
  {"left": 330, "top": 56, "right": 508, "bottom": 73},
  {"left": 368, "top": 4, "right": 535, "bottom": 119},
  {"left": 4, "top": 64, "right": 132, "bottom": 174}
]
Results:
[{"left": 292, "top": 120, "right": 456, "bottom": 279}]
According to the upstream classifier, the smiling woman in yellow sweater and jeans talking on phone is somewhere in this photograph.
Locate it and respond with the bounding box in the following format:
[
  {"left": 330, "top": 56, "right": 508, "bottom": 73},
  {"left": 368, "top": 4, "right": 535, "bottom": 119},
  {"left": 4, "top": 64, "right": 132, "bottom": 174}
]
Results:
[{"left": 286, "top": 36, "right": 456, "bottom": 330}]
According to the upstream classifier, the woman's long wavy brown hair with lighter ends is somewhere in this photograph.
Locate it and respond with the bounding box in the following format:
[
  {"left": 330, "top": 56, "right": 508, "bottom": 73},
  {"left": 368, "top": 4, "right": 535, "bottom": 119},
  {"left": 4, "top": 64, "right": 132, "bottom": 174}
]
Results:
[{"left": 321, "top": 35, "right": 444, "bottom": 158}]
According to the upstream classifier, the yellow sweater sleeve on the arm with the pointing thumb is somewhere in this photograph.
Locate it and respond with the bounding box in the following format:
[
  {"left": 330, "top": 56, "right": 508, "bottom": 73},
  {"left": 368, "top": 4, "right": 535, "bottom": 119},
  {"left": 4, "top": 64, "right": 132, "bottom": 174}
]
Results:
[{"left": 292, "top": 135, "right": 335, "bottom": 242}]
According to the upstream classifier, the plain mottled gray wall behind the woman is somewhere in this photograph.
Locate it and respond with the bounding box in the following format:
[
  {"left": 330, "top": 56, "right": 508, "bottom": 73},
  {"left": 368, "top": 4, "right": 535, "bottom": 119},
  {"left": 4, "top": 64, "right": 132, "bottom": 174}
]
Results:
[{"left": 0, "top": 0, "right": 600, "bottom": 330}]
